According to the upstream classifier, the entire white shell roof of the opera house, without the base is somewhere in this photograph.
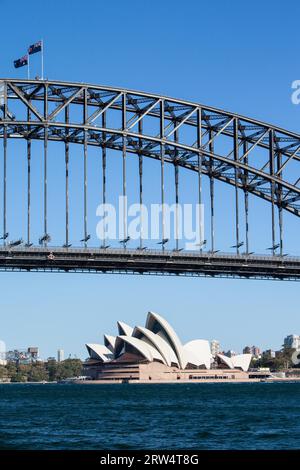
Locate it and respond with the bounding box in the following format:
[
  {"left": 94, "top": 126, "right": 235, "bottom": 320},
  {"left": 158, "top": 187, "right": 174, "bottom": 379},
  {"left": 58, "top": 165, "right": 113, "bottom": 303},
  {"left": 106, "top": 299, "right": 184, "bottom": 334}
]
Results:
[{"left": 86, "top": 312, "right": 252, "bottom": 372}]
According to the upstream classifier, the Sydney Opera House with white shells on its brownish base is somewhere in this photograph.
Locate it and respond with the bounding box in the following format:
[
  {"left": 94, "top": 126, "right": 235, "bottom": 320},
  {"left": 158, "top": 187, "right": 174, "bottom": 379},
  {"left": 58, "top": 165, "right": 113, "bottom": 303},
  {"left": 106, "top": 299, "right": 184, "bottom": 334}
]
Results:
[{"left": 84, "top": 312, "right": 251, "bottom": 383}]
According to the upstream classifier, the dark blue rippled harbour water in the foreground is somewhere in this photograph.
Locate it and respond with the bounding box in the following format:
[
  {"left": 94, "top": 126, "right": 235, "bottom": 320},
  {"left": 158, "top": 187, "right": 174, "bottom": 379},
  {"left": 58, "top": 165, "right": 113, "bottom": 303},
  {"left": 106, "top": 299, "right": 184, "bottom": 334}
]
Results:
[{"left": 0, "top": 383, "right": 300, "bottom": 450}]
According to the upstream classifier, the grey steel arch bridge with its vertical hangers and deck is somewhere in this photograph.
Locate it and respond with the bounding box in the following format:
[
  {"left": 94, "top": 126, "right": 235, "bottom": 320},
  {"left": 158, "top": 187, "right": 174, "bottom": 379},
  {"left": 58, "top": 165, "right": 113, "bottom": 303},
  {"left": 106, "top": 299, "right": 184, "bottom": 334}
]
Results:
[{"left": 0, "top": 79, "right": 300, "bottom": 279}]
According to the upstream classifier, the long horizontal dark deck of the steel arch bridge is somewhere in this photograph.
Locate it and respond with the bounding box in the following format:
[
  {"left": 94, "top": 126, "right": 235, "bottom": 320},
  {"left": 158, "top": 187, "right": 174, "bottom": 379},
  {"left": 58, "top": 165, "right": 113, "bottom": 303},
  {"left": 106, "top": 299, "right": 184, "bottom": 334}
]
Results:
[{"left": 0, "top": 246, "right": 300, "bottom": 280}]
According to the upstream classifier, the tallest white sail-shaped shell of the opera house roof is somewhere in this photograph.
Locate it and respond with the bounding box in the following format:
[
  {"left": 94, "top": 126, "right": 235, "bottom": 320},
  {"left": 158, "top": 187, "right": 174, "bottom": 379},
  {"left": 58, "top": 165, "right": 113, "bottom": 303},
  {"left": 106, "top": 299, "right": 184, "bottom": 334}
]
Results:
[{"left": 146, "top": 312, "right": 187, "bottom": 369}]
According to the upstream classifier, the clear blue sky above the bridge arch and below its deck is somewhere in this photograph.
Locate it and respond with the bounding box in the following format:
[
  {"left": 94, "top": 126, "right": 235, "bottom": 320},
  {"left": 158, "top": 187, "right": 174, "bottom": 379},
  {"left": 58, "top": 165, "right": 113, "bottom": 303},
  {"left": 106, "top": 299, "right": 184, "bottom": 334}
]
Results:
[{"left": 0, "top": 0, "right": 300, "bottom": 357}]
